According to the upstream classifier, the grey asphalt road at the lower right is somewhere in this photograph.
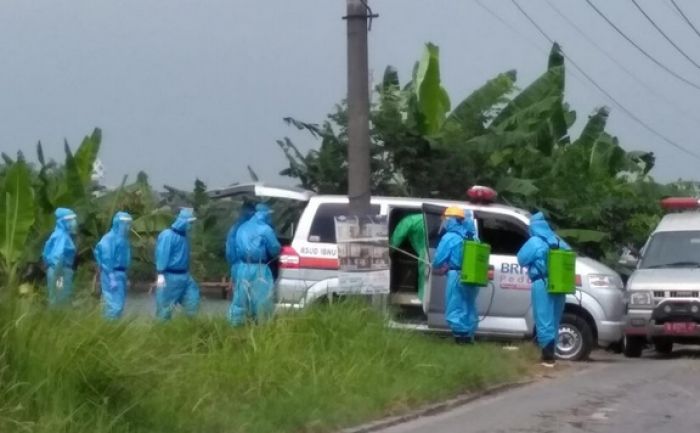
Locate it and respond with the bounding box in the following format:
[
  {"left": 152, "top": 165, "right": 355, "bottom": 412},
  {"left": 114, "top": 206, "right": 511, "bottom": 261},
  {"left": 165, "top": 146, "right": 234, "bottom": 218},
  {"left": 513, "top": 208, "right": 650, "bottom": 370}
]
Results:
[{"left": 382, "top": 348, "right": 700, "bottom": 433}]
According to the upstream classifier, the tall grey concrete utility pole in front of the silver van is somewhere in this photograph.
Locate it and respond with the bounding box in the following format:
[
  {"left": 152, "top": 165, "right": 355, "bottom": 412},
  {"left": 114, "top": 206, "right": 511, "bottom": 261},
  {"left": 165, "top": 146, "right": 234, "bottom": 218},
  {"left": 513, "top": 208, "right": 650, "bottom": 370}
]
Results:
[{"left": 343, "top": 0, "right": 376, "bottom": 216}]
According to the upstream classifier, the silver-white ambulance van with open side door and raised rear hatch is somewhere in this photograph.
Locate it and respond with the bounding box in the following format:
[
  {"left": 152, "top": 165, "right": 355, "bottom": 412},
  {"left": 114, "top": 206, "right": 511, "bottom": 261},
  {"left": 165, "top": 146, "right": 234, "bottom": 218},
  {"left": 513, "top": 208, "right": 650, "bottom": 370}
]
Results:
[{"left": 210, "top": 183, "right": 625, "bottom": 360}]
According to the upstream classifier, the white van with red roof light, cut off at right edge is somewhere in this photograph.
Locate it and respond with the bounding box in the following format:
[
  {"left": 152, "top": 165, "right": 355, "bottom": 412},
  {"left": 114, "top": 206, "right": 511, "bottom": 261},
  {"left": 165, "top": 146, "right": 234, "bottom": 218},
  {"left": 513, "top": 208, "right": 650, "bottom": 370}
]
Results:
[{"left": 625, "top": 197, "right": 700, "bottom": 358}]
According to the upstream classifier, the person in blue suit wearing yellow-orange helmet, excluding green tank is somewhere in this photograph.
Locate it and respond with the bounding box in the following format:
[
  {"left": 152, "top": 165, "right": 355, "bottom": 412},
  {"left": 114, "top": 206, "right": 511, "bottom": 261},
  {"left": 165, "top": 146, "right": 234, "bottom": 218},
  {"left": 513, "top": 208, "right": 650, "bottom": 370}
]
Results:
[{"left": 433, "top": 207, "right": 479, "bottom": 344}]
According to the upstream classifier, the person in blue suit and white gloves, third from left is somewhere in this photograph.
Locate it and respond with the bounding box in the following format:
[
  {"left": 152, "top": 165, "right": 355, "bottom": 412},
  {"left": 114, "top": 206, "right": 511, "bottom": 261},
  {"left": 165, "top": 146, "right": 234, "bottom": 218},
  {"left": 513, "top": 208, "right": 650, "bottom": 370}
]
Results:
[{"left": 155, "top": 209, "right": 199, "bottom": 320}]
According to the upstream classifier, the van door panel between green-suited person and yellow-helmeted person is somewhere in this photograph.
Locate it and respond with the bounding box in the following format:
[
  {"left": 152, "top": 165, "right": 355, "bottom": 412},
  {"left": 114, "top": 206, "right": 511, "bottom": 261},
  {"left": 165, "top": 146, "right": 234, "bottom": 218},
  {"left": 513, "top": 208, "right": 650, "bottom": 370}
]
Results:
[{"left": 423, "top": 204, "right": 446, "bottom": 328}]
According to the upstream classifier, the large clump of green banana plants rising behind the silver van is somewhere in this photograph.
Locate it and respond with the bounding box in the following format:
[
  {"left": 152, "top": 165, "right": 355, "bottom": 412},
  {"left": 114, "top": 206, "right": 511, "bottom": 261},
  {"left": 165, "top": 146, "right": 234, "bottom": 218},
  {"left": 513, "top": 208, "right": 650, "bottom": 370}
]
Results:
[{"left": 280, "top": 40, "right": 663, "bottom": 264}]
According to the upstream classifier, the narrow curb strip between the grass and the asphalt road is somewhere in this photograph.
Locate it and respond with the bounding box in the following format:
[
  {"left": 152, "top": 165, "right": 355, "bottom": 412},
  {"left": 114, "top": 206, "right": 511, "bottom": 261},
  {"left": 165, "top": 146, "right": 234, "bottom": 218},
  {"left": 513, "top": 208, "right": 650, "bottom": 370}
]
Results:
[{"left": 338, "top": 377, "right": 537, "bottom": 433}]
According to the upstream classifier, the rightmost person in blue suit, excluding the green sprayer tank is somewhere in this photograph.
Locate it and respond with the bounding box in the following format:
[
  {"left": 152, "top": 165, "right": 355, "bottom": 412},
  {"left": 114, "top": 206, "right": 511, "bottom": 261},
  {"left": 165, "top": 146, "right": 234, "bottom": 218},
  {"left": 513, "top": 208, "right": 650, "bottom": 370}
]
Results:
[{"left": 518, "top": 212, "right": 571, "bottom": 367}]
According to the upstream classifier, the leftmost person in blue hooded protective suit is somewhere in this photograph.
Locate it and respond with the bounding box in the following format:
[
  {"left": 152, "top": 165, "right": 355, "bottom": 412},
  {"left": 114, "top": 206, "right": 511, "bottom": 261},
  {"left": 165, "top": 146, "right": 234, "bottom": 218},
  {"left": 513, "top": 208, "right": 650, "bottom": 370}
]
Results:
[{"left": 42, "top": 208, "right": 78, "bottom": 306}]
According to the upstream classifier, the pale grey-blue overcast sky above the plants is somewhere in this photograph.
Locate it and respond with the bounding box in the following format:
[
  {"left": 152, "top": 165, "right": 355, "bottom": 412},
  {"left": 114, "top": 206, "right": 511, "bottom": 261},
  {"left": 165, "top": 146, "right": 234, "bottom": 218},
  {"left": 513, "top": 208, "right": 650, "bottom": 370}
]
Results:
[{"left": 0, "top": 0, "right": 700, "bottom": 187}]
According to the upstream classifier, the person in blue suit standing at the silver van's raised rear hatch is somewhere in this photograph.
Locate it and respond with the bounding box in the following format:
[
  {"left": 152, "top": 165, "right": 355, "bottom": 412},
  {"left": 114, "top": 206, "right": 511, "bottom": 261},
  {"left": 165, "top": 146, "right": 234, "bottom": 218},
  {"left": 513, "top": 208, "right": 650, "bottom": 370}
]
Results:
[{"left": 229, "top": 204, "right": 281, "bottom": 326}]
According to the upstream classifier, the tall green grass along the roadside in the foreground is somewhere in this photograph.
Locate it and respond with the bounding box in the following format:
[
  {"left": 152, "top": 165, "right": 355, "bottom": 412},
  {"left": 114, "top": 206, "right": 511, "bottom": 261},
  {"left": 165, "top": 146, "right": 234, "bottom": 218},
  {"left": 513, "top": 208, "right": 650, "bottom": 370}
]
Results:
[{"left": 0, "top": 305, "right": 532, "bottom": 433}]
